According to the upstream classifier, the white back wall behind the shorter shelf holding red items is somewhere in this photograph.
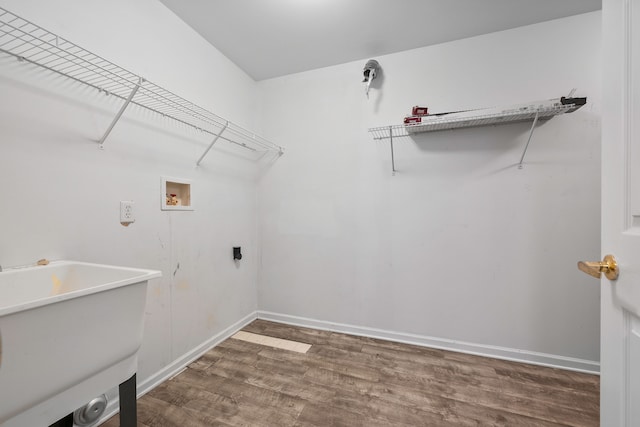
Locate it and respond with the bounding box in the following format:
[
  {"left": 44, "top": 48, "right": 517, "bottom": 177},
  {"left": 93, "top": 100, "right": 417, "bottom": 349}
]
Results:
[{"left": 258, "top": 12, "right": 600, "bottom": 369}]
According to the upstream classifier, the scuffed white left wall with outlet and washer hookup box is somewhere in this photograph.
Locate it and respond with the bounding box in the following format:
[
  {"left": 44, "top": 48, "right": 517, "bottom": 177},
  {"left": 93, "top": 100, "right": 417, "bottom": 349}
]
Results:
[{"left": 0, "top": 0, "right": 259, "bottom": 402}]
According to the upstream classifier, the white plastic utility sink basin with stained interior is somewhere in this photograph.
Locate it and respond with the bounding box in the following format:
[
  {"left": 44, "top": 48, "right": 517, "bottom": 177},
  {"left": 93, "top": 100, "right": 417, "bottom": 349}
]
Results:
[{"left": 0, "top": 261, "right": 161, "bottom": 427}]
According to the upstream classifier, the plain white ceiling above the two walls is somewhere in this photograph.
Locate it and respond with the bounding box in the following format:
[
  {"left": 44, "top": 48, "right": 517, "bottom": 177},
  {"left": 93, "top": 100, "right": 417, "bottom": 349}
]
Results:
[{"left": 160, "top": 0, "right": 602, "bottom": 80}]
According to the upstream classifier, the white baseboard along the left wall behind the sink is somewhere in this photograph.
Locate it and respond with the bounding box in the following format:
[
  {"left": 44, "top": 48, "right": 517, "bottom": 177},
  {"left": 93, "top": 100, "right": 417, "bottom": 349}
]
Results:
[{"left": 96, "top": 311, "right": 258, "bottom": 425}]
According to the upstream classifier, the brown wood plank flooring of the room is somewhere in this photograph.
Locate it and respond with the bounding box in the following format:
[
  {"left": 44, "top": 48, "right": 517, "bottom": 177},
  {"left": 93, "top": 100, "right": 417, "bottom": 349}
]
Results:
[{"left": 103, "top": 320, "right": 599, "bottom": 427}]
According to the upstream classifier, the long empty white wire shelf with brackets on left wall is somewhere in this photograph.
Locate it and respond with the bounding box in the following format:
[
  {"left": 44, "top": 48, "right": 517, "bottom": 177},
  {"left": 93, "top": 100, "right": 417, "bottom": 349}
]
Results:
[{"left": 0, "top": 8, "right": 284, "bottom": 164}]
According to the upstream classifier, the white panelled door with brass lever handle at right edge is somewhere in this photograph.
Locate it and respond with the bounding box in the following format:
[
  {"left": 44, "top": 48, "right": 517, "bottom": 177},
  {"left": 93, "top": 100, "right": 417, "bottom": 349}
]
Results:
[{"left": 600, "top": 0, "right": 640, "bottom": 427}]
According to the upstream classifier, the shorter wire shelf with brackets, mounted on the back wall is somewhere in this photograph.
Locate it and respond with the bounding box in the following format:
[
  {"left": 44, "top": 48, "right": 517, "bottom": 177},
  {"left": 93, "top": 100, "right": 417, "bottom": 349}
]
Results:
[{"left": 369, "top": 97, "right": 587, "bottom": 175}]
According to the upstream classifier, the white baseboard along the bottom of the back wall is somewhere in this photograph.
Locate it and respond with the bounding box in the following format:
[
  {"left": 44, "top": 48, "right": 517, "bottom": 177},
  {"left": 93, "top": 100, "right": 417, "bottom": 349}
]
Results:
[{"left": 258, "top": 311, "right": 600, "bottom": 375}]
